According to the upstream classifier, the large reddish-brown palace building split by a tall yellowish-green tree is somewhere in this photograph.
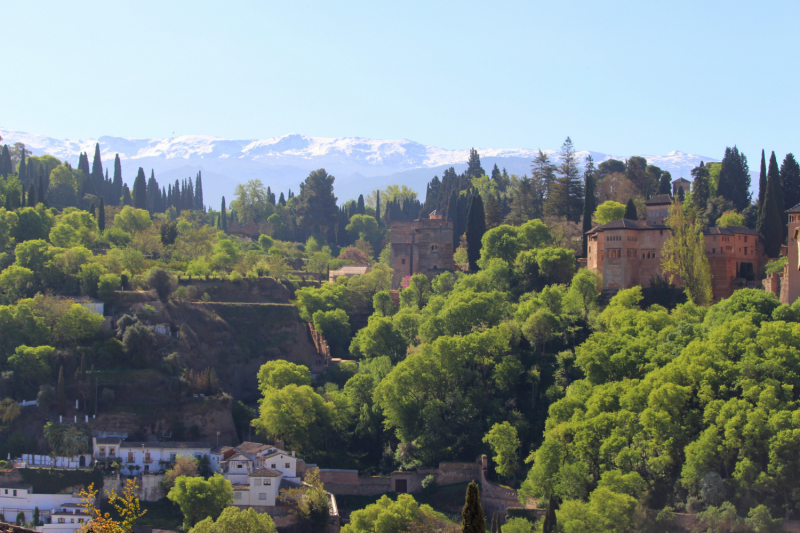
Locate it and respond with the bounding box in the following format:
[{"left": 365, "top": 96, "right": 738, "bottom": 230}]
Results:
[{"left": 587, "top": 194, "right": 766, "bottom": 300}]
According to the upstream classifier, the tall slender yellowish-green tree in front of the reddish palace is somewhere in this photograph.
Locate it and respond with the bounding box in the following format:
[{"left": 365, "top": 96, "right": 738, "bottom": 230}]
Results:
[{"left": 661, "top": 202, "right": 713, "bottom": 306}]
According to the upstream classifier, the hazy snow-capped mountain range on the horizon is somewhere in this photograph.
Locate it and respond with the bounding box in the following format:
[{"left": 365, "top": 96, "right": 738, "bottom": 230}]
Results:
[{"left": 0, "top": 128, "right": 718, "bottom": 207}]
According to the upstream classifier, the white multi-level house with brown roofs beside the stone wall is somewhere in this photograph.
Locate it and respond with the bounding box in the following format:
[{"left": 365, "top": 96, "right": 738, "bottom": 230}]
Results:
[{"left": 217, "top": 442, "right": 301, "bottom": 508}]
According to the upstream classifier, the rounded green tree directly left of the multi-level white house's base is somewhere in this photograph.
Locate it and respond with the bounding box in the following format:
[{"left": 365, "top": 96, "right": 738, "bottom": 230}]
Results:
[{"left": 167, "top": 474, "right": 233, "bottom": 531}]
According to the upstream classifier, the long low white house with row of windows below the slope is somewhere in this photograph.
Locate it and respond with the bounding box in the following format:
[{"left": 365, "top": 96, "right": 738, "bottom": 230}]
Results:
[{"left": 92, "top": 437, "right": 211, "bottom": 474}]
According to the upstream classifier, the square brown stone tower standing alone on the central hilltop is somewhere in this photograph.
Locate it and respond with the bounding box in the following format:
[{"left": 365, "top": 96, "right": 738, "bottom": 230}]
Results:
[{"left": 389, "top": 211, "right": 454, "bottom": 290}]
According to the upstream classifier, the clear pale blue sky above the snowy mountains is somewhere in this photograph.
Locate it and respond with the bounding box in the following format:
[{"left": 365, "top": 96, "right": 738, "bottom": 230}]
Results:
[{"left": 0, "top": 0, "right": 800, "bottom": 161}]
